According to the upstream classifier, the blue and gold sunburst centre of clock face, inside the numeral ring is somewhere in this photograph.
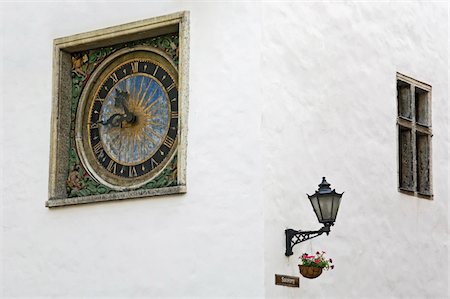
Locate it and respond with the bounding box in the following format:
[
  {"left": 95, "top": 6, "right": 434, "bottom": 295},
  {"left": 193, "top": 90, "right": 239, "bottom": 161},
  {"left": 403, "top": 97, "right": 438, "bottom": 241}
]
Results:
[{"left": 97, "top": 75, "right": 170, "bottom": 168}]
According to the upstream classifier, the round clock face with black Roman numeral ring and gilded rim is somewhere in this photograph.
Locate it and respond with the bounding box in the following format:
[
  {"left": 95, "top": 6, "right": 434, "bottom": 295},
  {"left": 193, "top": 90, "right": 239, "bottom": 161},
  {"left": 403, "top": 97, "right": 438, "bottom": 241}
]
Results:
[{"left": 76, "top": 48, "right": 178, "bottom": 190}]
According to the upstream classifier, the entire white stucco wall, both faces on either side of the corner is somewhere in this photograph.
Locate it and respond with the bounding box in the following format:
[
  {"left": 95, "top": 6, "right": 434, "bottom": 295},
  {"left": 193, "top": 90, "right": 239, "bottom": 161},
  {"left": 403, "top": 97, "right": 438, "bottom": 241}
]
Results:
[{"left": 0, "top": 1, "right": 449, "bottom": 299}]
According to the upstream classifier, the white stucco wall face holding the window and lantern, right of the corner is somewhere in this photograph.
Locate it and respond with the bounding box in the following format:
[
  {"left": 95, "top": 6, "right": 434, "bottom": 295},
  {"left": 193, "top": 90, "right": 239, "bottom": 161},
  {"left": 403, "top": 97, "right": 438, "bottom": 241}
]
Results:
[{"left": 262, "top": 2, "right": 449, "bottom": 298}]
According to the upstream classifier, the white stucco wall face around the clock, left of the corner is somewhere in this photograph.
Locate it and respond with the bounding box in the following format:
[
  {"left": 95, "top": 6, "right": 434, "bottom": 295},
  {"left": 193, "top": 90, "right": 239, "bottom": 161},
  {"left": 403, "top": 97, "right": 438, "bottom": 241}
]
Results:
[{"left": 0, "top": 2, "right": 264, "bottom": 298}]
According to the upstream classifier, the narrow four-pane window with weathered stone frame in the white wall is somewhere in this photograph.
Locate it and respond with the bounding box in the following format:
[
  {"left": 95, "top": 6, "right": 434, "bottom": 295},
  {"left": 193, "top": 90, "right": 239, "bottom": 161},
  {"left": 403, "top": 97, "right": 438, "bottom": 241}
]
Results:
[{"left": 397, "top": 73, "right": 433, "bottom": 198}]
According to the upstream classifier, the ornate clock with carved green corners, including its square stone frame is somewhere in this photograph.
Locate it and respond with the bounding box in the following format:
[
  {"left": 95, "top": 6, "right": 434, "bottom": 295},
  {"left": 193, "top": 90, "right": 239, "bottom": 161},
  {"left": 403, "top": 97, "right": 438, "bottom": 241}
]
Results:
[{"left": 46, "top": 12, "right": 188, "bottom": 207}]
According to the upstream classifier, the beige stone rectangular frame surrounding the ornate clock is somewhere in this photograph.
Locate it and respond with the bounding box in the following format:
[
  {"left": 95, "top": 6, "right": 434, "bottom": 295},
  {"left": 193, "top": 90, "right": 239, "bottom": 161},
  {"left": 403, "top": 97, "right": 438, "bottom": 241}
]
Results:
[{"left": 46, "top": 11, "right": 189, "bottom": 207}]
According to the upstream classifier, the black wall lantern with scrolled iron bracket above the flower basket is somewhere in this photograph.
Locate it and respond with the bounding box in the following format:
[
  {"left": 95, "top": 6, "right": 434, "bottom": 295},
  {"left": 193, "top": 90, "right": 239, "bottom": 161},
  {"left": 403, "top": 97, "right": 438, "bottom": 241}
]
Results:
[{"left": 284, "top": 177, "right": 344, "bottom": 256}]
